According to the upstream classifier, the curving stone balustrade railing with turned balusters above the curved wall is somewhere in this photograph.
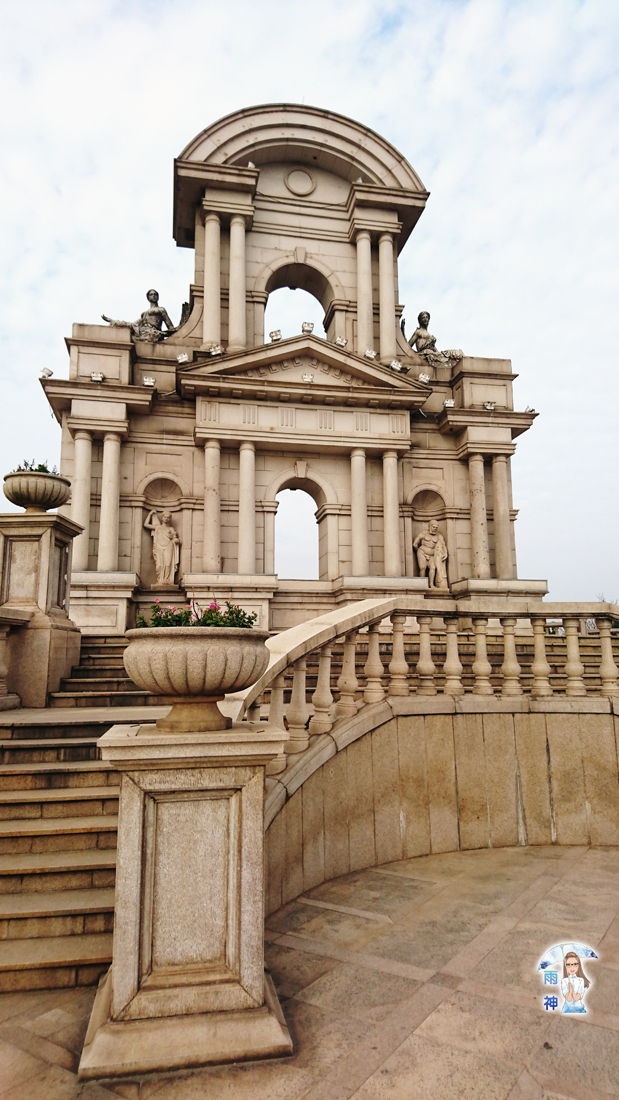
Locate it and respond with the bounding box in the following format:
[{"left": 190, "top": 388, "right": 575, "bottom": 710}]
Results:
[{"left": 227, "top": 598, "right": 619, "bottom": 770}]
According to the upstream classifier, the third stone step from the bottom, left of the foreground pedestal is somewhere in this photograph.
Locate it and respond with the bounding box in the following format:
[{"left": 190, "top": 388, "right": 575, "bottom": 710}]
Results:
[{"left": 0, "top": 848, "right": 117, "bottom": 894}]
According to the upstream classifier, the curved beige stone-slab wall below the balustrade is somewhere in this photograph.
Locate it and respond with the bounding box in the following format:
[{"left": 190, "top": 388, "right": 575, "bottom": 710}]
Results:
[{"left": 266, "top": 699, "right": 619, "bottom": 913}]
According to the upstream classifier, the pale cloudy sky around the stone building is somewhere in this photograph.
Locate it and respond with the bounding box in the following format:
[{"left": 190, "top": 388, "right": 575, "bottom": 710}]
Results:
[{"left": 0, "top": 0, "right": 619, "bottom": 600}]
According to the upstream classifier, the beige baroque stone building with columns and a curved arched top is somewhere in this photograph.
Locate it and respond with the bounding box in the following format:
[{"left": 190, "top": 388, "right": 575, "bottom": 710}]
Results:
[{"left": 44, "top": 105, "right": 546, "bottom": 634}]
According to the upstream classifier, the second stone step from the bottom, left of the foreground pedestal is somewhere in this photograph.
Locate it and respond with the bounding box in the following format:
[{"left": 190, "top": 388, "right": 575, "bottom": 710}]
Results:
[{"left": 0, "top": 887, "right": 114, "bottom": 941}]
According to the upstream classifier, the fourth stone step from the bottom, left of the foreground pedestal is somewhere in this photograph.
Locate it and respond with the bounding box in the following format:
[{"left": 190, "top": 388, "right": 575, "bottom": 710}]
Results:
[{"left": 0, "top": 814, "right": 118, "bottom": 856}]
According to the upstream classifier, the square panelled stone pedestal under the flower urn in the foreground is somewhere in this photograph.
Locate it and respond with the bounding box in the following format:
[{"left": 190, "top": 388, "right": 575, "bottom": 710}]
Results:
[{"left": 79, "top": 722, "right": 292, "bottom": 1079}]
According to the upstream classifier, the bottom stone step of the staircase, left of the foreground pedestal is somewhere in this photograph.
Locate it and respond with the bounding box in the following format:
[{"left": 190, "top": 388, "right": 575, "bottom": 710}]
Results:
[{"left": 0, "top": 932, "right": 112, "bottom": 993}]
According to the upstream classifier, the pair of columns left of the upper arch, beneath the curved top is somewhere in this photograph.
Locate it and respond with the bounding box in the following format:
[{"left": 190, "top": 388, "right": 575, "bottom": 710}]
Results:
[{"left": 202, "top": 212, "right": 247, "bottom": 352}]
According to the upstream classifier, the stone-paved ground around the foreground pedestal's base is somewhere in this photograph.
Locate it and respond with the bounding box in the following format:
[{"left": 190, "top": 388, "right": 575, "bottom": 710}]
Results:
[{"left": 0, "top": 848, "right": 619, "bottom": 1100}]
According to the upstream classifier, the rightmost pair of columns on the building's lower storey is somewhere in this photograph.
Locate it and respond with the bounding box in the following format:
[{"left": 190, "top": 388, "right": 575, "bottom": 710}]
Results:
[{"left": 468, "top": 454, "right": 513, "bottom": 580}]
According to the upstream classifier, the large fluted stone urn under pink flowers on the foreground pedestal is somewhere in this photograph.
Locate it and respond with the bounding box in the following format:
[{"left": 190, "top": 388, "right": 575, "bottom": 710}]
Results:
[{"left": 123, "top": 626, "right": 269, "bottom": 733}]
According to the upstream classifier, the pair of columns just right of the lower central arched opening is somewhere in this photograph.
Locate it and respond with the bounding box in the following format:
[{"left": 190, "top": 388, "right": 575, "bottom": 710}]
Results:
[{"left": 351, "top": 448, "right": 402, "bottom": 576}]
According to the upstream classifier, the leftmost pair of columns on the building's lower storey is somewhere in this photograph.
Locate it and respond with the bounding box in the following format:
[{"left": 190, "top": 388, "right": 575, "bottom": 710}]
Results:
[{"left": 71, "top": 430, "right": 121, "bottom": 573}]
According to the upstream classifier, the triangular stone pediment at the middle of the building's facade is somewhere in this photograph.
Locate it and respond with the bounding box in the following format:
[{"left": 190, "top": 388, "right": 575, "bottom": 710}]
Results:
[{"left": 178, "top": 336, "right": 429, "bottom": 399}]
